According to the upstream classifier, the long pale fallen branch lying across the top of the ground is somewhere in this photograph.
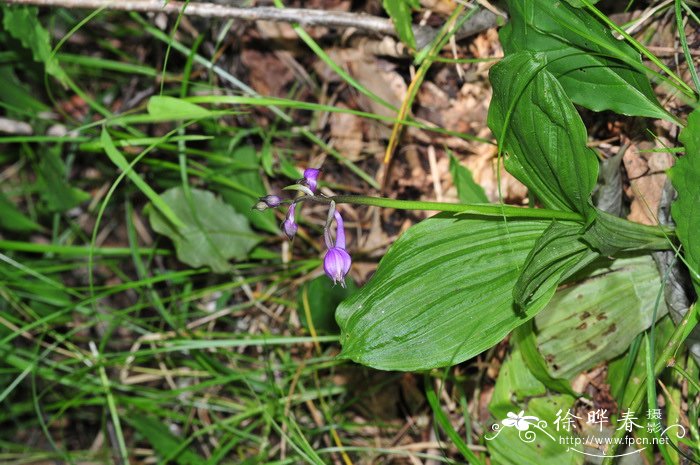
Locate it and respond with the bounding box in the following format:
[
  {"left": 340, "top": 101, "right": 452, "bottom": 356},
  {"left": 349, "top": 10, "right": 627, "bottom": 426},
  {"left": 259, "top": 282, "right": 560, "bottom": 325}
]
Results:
[{"left": 0, "top": 0, "right": 497, "bottom": 48}]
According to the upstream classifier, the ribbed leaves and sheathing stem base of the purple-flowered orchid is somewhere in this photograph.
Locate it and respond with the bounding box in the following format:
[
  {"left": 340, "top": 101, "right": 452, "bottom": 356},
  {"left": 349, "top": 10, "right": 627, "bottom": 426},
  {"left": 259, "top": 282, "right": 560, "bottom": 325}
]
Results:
[{"left": 337, "top": 4, "right": 680, "bottom": 374}]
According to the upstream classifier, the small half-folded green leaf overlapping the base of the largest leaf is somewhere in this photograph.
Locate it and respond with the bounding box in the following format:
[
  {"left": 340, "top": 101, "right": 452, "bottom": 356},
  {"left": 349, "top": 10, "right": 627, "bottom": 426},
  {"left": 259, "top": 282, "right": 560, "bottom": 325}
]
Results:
[{"left": 513, "top": 221, "right": 598, "bottom": 307}]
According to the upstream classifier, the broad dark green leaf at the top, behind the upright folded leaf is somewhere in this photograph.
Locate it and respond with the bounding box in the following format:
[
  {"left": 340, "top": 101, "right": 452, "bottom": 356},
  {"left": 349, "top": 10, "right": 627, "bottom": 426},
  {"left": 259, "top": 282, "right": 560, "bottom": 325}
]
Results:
[{"left": 500, "top": 0, "right": 673, "bottom": 121}]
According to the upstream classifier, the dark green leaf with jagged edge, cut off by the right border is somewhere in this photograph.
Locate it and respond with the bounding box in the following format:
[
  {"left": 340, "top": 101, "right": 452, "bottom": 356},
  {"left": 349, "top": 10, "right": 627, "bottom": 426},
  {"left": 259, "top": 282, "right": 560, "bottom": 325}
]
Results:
[{"left": 669, "top": 109, "right": 700, "bottom": 294}]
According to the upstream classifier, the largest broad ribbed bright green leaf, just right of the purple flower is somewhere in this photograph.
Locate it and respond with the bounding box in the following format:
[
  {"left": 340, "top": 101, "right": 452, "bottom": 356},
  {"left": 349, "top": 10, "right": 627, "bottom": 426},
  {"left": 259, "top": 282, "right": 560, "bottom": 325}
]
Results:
[{"left": 336, "top": 214, "right": 554, "bottom": 370}]
